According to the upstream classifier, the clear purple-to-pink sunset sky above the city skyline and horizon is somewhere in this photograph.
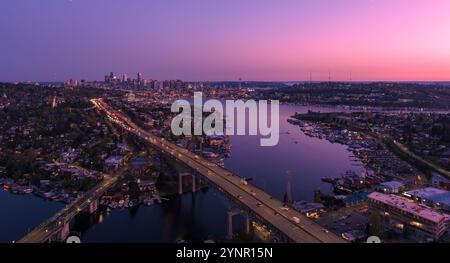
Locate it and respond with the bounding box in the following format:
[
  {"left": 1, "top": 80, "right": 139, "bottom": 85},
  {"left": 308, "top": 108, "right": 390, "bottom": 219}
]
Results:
[{"left": 0, "top": 0, "right": 450, "bottom": 81}]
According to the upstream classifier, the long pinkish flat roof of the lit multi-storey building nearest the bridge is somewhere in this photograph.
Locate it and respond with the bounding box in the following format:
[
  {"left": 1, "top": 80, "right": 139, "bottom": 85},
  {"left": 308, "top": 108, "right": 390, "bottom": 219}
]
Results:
[{"left": 369, "top": 192, "right": 445, "bottom": 223}]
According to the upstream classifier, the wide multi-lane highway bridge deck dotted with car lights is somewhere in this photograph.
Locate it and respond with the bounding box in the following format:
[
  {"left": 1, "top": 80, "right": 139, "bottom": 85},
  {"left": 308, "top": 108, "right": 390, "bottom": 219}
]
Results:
[{"left": 93, "top": 99, "right": 345, "bottom": 243}]
